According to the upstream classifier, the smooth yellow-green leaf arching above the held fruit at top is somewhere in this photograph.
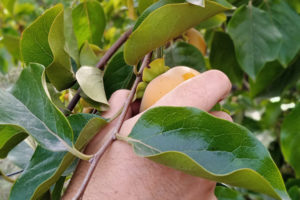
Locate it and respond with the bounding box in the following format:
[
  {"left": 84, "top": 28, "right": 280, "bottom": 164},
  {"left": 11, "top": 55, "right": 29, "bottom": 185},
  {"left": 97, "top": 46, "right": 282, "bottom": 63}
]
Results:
[{"left": 124, "top": 1, "right": 228, "bottom": 65}]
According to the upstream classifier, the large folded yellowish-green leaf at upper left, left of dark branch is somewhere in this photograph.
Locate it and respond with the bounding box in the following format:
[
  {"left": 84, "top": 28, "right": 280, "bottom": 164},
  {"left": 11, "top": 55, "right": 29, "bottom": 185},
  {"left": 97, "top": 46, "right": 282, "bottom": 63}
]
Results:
[{"left": 20, "top": 4, "right": 74, "bottom": 90}]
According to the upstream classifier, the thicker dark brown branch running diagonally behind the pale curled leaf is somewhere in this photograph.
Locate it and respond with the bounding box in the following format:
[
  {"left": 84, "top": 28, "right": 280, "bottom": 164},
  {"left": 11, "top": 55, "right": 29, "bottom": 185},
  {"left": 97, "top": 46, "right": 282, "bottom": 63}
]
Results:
[{"left": 67, "top": 28, "right": 132, "bottom": 112}]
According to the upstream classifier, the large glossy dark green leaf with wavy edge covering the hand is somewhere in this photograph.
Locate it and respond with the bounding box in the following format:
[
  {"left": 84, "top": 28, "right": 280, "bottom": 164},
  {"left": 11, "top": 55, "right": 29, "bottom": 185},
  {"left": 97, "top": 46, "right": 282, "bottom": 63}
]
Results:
[{"left": 127, "top": 107, "right": 289, "bottom": 199}]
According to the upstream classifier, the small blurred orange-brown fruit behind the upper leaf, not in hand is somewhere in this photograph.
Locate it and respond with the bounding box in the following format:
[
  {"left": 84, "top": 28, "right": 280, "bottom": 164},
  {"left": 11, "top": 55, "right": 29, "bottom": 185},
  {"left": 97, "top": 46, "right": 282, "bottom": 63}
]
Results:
[{"left": 185, "top": 28, "right": 206, "bottom": 55}]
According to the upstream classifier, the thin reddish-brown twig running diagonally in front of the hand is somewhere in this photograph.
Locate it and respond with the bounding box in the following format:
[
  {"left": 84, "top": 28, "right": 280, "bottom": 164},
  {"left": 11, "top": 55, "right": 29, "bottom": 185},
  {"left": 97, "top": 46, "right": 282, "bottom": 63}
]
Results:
[{"left": 73, "top": 53, "right": 152, "bottom": 200}]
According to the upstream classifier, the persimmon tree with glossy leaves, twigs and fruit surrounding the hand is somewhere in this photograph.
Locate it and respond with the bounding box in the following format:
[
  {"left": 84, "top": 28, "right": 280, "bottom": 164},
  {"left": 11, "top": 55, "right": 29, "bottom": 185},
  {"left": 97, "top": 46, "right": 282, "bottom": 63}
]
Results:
[{"left": 0, "top": 0, "right": 300, "bottom": 200}]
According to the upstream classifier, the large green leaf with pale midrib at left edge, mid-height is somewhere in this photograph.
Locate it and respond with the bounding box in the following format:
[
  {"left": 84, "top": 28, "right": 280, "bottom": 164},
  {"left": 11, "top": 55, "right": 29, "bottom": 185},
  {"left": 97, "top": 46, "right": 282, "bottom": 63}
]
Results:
[{"left": 0, "top": 64, "right": 73, "bottom": 151}]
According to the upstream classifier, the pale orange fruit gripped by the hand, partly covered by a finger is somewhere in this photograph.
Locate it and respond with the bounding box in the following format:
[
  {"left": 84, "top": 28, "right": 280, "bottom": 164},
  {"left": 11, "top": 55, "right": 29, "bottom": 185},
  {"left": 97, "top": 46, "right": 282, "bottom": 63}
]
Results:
[{"left": 140, "top": 66, "right": 200, "bottom": 112}]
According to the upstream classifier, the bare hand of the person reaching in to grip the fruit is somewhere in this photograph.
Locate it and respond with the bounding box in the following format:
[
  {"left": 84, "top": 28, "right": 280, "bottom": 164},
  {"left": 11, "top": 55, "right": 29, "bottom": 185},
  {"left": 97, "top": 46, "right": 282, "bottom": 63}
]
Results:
[{"left": 63, "top": 70, "right": 232, "bottom": 200}]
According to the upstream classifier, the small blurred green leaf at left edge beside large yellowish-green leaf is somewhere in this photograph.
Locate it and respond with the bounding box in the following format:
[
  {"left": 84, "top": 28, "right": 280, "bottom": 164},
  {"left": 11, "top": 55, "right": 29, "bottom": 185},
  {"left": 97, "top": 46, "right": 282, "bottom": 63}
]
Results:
[{"left": 2, "top": 34, "right": 20, "bottom": 60}]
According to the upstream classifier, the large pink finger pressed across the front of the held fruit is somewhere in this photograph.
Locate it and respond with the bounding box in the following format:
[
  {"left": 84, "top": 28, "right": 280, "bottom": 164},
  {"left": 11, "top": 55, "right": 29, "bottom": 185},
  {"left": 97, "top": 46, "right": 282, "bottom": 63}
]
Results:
[{"left": 153, "top": 70, "right": 231, "bottom": 111}]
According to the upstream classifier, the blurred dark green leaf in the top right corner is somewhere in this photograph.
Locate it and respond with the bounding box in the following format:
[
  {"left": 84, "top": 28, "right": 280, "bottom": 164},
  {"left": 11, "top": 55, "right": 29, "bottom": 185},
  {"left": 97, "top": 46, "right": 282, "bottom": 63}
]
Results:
[{"left": 264, "top": 0, "right": 300, "bottom": 67}]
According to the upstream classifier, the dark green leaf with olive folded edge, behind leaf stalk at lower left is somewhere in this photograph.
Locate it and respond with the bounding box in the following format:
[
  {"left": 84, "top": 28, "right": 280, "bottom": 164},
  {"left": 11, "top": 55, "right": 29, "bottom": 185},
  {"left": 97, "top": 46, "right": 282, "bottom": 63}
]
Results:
[{"left": 10, "top": 114, "right": 106, "bottom": 200}]
